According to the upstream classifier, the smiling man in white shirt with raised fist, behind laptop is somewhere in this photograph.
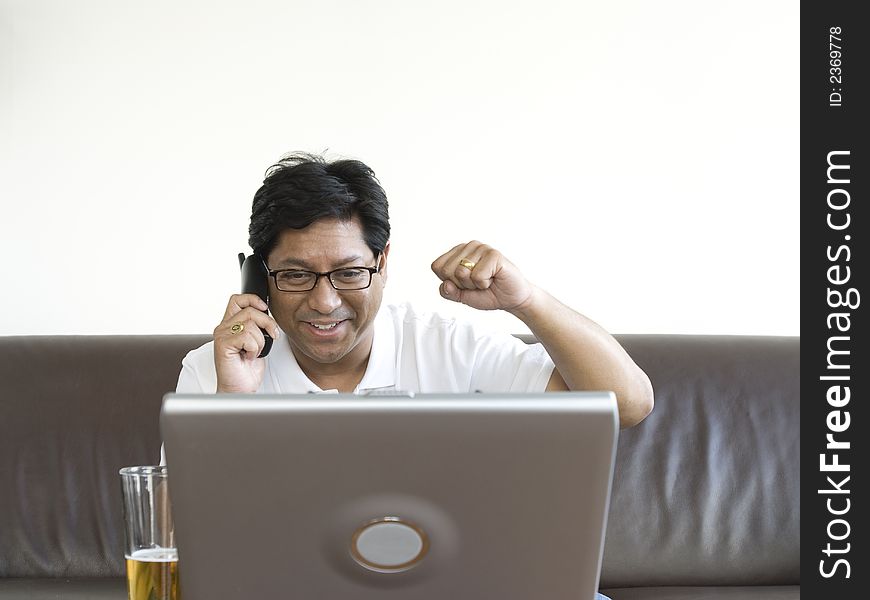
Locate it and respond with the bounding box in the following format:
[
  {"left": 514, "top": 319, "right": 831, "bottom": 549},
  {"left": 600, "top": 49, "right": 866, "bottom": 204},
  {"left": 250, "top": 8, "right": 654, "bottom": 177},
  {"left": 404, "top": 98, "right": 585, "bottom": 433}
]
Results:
[{"left": 177, "top": 154, "right": 653, "bottom": 427}]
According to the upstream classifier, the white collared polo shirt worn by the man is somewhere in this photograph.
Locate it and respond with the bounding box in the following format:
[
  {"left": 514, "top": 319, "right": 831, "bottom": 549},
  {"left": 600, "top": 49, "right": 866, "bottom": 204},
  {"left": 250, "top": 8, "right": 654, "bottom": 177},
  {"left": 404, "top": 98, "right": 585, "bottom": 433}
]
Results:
[{"left": 176, "top": 304, "right": 554, "bottom": 394}]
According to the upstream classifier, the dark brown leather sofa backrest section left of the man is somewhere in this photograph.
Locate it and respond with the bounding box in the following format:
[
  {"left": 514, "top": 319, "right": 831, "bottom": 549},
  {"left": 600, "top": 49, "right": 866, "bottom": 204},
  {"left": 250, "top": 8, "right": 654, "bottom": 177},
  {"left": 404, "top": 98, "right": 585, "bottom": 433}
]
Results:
[{"left": 0, "top": 336, "right": 207, "bottom": 577}]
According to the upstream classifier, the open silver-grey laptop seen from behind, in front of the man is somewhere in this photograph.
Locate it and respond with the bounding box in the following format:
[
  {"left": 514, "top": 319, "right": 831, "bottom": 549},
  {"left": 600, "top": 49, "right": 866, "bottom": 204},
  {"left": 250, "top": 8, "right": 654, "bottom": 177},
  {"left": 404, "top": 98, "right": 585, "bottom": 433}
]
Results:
[{"left": 160, "top": 392, "right": 618, "bottom": 600}]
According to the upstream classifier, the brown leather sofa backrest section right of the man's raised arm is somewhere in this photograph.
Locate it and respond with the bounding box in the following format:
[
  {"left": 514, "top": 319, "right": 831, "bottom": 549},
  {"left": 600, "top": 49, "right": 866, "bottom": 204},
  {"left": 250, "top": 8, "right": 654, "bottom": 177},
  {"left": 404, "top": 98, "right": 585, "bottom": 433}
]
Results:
[{"left": 601, "top": 335, "right": 800, "bottom": 588}]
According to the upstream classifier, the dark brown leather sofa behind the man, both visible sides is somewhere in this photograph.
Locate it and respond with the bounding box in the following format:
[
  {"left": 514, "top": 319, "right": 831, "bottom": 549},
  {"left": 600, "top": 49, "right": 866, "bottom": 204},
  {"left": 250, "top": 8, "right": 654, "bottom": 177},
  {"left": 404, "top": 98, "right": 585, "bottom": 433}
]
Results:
[{"left": 0, "top": 335, "right": 800, "bottom": 600}]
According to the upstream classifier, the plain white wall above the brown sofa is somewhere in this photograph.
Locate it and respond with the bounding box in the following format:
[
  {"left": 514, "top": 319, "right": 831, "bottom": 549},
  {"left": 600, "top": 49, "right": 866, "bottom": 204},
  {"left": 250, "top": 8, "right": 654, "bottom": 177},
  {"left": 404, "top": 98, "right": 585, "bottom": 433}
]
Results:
[{"left": 0, "top": 0, "right": 800, "bottom": 335}]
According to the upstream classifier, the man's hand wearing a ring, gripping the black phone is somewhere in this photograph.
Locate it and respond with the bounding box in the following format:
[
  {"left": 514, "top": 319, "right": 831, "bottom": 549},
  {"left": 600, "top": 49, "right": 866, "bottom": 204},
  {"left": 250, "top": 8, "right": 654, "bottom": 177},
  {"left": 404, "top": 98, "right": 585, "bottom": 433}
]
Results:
[{"left": 214, "top": 294, "right": 280, "bottom": 394}]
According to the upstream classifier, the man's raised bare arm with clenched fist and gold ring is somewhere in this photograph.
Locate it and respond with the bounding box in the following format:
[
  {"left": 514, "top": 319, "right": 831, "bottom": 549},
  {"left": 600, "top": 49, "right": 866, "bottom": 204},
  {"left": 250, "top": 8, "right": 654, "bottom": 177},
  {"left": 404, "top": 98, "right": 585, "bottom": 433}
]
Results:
[{"left": 432, "top": 241, "right": 653, "bottom": 428}]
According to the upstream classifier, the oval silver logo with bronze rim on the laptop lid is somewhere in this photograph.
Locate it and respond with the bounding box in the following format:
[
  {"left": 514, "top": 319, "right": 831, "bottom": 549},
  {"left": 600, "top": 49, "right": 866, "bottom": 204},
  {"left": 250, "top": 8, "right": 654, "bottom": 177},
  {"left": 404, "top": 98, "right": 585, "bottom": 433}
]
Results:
[{"left": 350, "top": 517, "right": 429, "bottom": 573}]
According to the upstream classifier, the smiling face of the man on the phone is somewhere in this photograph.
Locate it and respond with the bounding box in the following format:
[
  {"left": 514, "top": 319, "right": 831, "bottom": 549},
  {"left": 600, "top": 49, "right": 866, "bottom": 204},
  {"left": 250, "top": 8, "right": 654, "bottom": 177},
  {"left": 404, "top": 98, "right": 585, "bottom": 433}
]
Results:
[{"left": 266, "top": 218, "right": 390, "bottom": 371}]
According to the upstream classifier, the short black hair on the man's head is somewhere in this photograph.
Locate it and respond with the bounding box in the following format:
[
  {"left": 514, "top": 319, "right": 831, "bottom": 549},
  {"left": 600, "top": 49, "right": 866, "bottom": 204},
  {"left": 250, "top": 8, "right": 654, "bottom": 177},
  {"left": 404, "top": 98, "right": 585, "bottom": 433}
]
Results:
[{"left": 248, "top": 152, "right": 390, "bottom": 257}]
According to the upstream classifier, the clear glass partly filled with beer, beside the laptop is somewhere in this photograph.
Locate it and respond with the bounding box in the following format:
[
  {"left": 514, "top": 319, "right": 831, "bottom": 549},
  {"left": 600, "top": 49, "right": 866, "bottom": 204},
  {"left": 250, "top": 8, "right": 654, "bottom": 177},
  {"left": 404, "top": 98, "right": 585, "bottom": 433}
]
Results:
[{"left": 120, "top": 466, "right": 180, "bottom": 600}]
